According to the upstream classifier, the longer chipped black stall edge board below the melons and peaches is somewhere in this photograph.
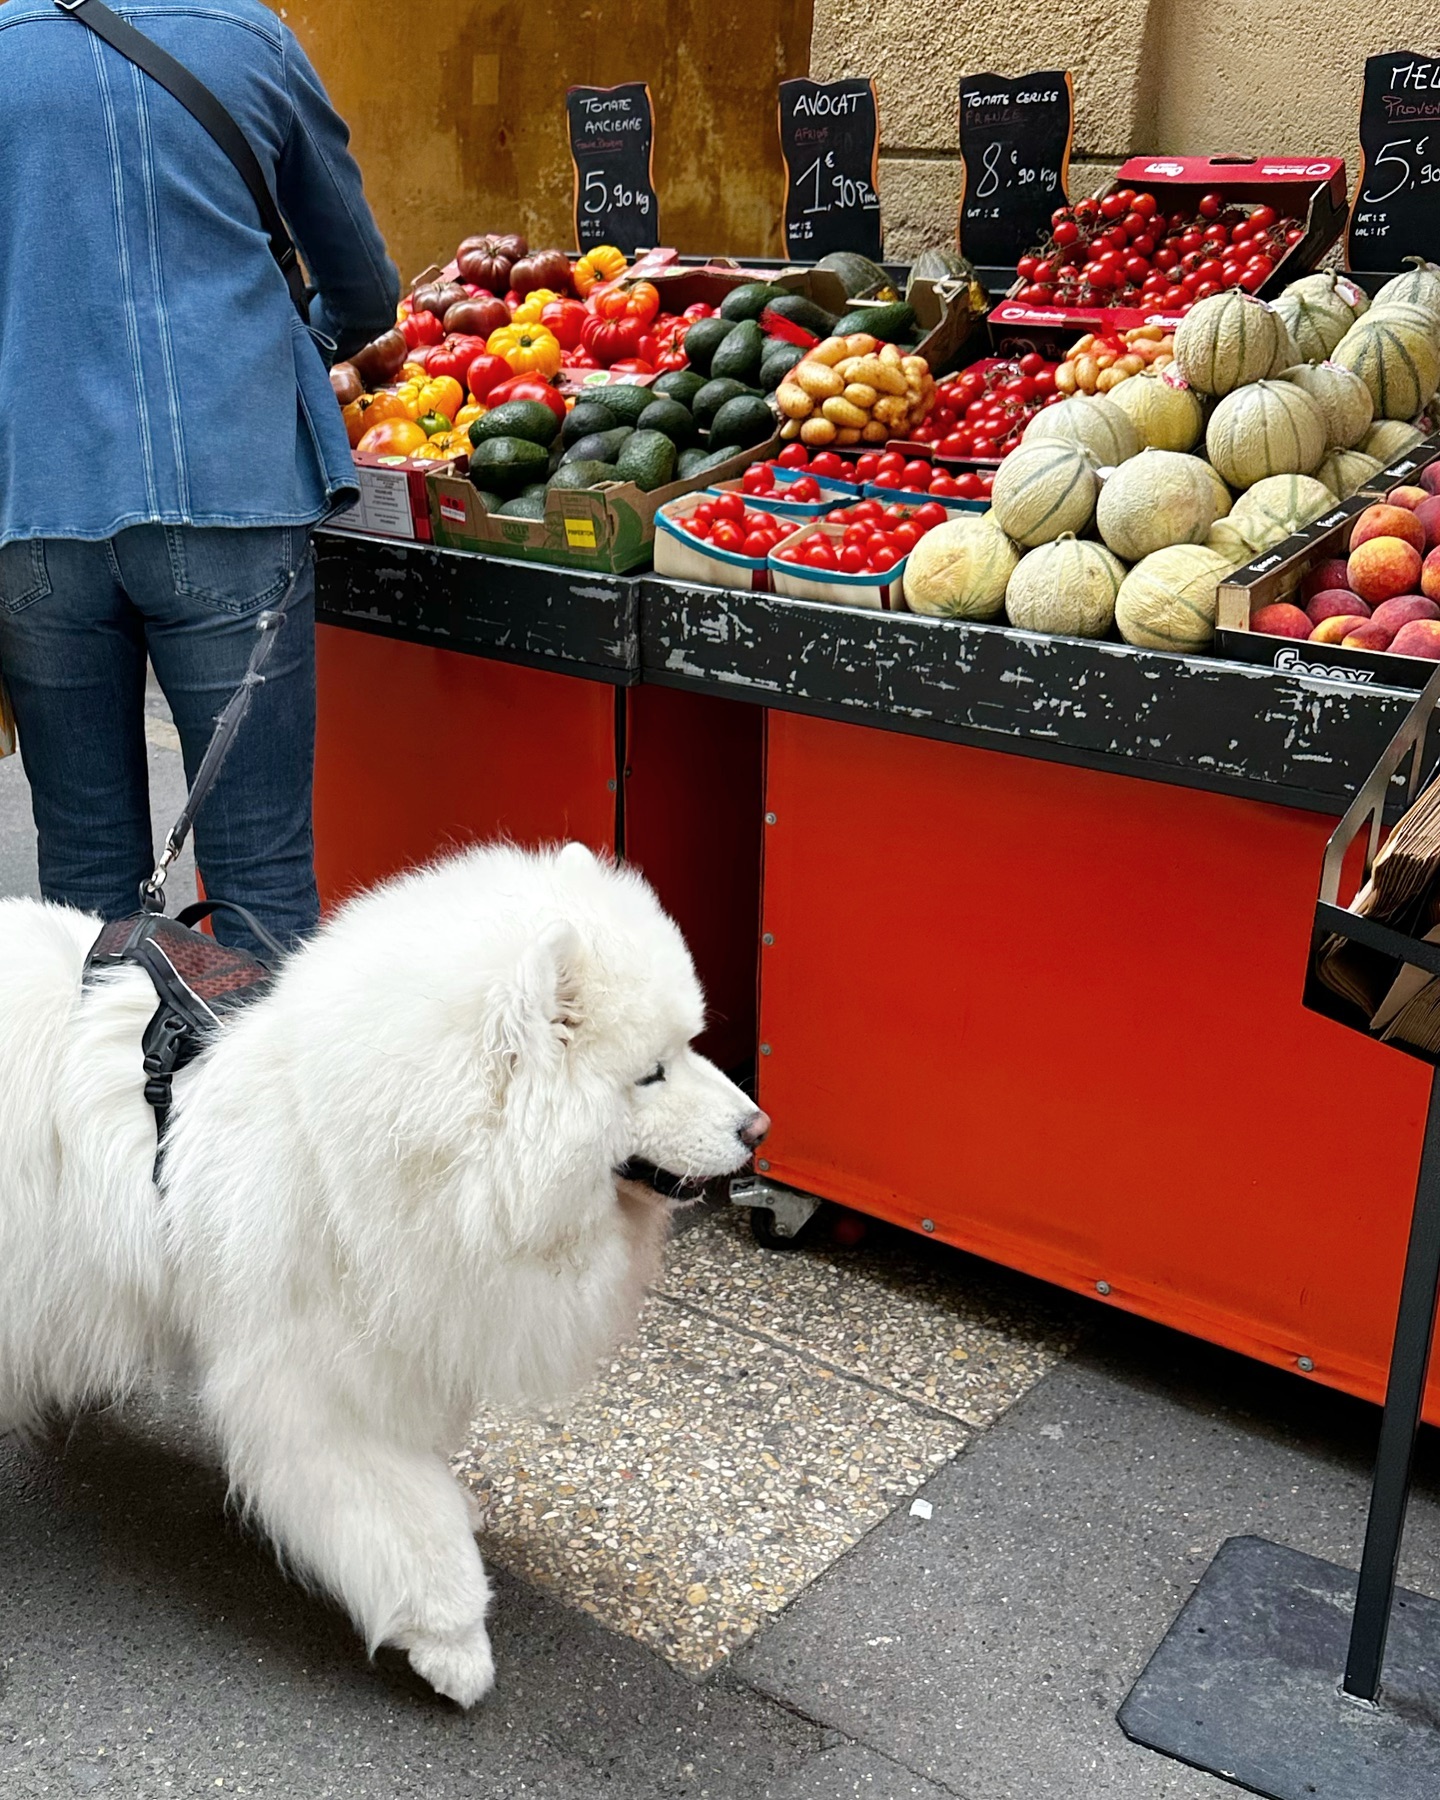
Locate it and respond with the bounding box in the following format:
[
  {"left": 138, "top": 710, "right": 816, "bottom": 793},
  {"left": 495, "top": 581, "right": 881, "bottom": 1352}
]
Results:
[{"left": 641, "top": 578, "right": 1415, "bottom": 812}]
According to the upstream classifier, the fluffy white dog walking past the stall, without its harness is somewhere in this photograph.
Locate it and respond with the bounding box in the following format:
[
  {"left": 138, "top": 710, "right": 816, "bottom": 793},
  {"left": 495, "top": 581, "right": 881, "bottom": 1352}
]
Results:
[{"left": 0, "top": 844, "right": 769, "bottom": 1705}]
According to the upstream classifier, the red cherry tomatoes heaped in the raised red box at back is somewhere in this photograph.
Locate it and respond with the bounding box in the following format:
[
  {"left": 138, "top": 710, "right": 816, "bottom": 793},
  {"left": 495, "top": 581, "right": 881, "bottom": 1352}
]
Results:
[{"left": 1012, "top": 187, "right": 1305, "bottom": 313}]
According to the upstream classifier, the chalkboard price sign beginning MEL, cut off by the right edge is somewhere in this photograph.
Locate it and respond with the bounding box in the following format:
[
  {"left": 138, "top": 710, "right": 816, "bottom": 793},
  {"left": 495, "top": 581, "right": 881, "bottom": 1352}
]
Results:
[{"left": 1345, "top": 50, "right": 1440, "bottom": 268}]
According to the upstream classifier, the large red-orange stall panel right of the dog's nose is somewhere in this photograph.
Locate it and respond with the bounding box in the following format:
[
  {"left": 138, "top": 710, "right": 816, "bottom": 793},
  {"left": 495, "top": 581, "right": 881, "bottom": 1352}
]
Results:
[{"left": 760, "top": 713, "right": 1440, "bottom": 1422}]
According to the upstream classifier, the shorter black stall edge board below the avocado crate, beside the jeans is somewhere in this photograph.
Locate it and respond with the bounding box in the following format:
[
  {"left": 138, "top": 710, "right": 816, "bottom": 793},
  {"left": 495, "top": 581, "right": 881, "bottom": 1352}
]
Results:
[{"left": 315, "top": 531, "right": 639, "bottom": 688}]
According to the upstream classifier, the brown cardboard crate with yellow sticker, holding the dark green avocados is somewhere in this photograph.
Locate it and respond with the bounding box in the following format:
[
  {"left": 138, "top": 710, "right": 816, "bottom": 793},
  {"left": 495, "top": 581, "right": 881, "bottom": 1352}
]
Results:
[{"left": 428, "top": 437, "right": 779, "bottom": 574}]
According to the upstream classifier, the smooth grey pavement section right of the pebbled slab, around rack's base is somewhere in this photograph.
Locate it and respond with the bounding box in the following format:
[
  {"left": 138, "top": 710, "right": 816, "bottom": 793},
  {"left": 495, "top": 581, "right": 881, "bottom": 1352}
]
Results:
[{"left": 734, "top": 1316, "right": 1440, "bottom": 1800}]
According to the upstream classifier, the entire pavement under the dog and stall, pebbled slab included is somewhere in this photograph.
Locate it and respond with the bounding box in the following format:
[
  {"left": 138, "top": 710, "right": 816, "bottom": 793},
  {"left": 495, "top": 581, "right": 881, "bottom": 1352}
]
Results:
[{"left": 0, "top": 720, "right": 1440, "bottom": 1800}]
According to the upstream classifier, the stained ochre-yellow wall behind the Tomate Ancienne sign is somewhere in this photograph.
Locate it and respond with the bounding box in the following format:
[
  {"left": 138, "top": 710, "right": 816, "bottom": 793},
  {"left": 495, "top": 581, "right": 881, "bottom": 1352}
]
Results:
[{"left": 286, "top": 0, "right": 812, "bottom": 275}]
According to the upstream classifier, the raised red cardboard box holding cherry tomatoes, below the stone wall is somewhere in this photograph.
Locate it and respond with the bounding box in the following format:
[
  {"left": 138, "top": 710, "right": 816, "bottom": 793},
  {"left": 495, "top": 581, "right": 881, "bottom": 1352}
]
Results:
[{"left": 988, "top": 157, "right": 1345, "bottom": 356}]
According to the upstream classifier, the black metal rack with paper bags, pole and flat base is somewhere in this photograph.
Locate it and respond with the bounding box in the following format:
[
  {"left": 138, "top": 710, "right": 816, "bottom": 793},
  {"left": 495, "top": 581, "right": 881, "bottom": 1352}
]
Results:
[{"left": 1120, "top": 673, "right": 1440, "bottom": 1800}]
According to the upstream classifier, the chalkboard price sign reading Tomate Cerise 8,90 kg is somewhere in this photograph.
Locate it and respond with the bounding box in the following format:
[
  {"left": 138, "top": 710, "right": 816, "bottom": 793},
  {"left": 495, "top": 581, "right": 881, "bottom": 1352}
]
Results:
[{"left": 959, "top": 68, "right": 1075, "bottom": 268}]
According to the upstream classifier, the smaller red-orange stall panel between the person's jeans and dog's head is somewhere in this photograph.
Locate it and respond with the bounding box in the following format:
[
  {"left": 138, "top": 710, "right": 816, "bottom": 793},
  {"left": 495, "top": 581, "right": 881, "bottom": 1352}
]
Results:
[{"left": 315, "top": 625, "right": 617, "bottom": 905}]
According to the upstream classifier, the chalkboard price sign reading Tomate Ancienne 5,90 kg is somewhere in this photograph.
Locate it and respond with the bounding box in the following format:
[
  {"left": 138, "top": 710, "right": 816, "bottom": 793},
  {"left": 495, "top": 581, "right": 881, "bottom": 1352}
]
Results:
[{"left": 565, "top": 81, "right": 661, "bottom": 256}]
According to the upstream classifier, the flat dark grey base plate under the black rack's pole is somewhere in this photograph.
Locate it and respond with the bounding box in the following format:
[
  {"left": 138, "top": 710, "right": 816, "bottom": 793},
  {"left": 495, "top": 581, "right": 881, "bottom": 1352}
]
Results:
[{"left": 1120, "top": 1537, "right": 1440, "bottom": 1800}]
